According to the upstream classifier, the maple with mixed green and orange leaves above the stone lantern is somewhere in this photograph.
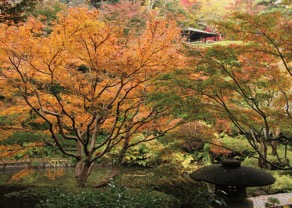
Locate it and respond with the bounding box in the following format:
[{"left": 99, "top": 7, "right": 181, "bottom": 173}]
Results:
[{"left": 184, "top": 10, "right": 292, "bottom": 169}]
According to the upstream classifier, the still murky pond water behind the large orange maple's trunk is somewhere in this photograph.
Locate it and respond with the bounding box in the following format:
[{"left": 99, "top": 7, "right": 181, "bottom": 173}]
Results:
[{"left": 0, "top": 165, "right": 154, "bottom": 187}]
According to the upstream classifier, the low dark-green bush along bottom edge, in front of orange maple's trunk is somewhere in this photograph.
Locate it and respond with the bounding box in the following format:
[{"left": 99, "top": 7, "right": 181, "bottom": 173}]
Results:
[{"left": 0, "top": 185, "right": 179, "bottom": 208}]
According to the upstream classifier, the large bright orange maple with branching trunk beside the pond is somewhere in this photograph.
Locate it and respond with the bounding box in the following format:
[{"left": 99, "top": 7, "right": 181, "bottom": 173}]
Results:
[{"left": 0, "top": 7, "right": 180, "bottom": 187}]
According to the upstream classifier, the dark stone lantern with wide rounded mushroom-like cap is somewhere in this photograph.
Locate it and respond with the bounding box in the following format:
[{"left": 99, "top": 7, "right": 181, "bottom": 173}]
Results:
[{"left": 190, "top": 160, "right": 275, "bottom": 206}]
